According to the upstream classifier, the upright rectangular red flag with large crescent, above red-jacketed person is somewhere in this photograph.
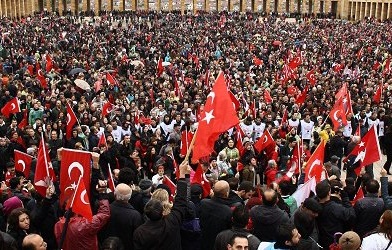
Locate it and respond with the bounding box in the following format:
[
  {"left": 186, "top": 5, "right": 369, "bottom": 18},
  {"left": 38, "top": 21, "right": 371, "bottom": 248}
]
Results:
[{"left": 60, "top": 148, "right": 91, "bottom": 205}]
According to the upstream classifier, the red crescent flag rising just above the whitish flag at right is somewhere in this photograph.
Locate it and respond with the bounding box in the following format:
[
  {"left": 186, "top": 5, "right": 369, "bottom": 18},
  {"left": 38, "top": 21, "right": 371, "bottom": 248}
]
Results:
[{"left": 305, "top": 140, "right": 325, "bottom": 183}]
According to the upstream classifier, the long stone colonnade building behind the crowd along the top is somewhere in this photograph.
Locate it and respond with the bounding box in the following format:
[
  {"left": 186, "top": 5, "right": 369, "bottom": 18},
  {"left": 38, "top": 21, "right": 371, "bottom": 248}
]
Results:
[{"left": 0, "top": 0, "right": 392, "bottom": 20}]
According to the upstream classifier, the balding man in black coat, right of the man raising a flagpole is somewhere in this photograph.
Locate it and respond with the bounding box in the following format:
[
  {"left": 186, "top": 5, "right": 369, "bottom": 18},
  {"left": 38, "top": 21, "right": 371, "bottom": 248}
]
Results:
[{"left": 200, "top": 181, "right": 232, "bottom": 250}]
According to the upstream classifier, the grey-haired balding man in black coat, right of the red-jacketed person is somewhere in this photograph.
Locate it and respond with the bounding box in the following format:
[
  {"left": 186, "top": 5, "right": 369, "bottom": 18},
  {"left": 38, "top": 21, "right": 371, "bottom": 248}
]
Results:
[{"left": 104, "top": 183, "right": 143, "bottom": 250}]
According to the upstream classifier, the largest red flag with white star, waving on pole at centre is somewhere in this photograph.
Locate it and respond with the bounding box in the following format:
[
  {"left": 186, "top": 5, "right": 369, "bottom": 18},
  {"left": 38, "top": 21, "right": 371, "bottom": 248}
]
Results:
[{"left": 193, "top": 72, "right": 240, "bottom": 161}]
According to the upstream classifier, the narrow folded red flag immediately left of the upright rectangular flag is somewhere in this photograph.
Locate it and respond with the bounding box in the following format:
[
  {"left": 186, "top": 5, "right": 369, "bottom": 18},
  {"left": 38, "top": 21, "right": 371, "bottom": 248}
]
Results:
[{"left": 34, "top": 135, "right": 56, "bottom": 197}]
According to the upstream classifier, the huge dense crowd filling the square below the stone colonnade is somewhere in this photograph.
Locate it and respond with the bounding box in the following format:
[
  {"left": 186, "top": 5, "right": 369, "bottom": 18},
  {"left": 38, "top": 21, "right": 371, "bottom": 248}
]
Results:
[{"left": 0, "top": 12, "right": 392, "bottom": 250}]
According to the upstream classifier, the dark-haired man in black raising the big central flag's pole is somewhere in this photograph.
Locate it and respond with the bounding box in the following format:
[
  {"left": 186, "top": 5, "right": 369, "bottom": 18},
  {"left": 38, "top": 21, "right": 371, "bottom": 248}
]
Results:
[{"left": 133, "top": 162, "right": 190, "bottom": 250}]
